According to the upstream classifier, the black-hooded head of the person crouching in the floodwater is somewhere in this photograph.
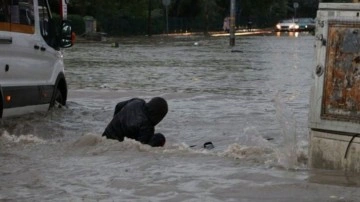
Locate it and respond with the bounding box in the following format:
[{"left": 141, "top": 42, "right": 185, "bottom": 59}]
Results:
[{"left": 146, "top": 97, "right": 168, "bottom": 126}]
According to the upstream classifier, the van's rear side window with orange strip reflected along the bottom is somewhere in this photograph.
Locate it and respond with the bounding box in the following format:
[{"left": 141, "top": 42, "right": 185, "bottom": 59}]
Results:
[{"left": 0, "top": 0, "right": 35, "bottom": 34}]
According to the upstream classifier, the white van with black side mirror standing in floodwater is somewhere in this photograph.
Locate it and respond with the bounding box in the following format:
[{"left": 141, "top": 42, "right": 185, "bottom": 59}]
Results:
[{"left": 0, "top": 0, "right": 73, "bottom": 118}]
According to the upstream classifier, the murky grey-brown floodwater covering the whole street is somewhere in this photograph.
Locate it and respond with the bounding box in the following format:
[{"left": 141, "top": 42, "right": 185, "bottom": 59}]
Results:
[{"left": 0, "top": 33, "right": 360, "bottom": 202}]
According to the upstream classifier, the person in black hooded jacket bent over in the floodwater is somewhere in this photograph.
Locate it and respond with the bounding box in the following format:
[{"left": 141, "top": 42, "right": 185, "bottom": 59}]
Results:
[{"left": 102, "top": 97, "right": 168, "bottom": 147}]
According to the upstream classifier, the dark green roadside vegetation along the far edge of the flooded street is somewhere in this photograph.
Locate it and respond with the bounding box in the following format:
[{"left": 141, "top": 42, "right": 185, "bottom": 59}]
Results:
[{"left": 52, "top": 0, "right": 352, "bottom": 36}]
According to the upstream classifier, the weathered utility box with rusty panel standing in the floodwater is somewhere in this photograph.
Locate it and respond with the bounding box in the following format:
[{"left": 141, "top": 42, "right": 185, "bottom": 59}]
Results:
[{"left": 309, "top": 3, "right": 360, "bottom": 172}]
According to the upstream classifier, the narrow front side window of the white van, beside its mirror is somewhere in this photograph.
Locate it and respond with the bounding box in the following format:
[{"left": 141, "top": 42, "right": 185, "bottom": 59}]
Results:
[{"left": 39, "top": 0, "right": 59, "bottom": 50}]
